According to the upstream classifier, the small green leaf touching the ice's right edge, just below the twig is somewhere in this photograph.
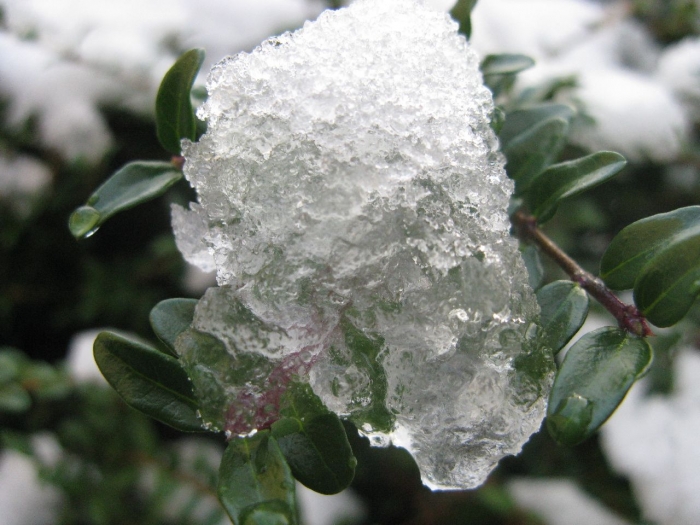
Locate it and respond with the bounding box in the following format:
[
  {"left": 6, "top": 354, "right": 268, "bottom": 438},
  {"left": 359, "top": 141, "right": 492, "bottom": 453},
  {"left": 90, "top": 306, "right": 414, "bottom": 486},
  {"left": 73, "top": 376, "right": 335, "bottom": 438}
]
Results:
[{"left": 537, "top": 281, "right": 589, "bottom": 355}]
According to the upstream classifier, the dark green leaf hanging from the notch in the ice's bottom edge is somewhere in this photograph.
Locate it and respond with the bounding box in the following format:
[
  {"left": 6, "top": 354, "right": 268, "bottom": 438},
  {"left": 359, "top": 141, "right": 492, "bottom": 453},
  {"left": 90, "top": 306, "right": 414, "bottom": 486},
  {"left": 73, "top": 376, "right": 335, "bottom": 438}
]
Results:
[{"left": 272, "top": 384, "right": 357, "bottom": 494}]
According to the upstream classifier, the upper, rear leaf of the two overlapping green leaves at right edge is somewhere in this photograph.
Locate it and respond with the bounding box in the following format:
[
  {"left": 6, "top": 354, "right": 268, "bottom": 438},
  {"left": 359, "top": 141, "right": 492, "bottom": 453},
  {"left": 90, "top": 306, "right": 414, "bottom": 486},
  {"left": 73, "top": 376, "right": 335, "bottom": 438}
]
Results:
[{"left": 600, "top": 206, "right": 700, "bottom": 290}]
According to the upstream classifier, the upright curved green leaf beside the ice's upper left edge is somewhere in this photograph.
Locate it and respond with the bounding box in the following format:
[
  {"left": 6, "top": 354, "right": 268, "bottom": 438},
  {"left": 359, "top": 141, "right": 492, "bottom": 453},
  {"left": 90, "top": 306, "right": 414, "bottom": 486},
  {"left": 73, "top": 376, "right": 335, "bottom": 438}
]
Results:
[{"left": 156, "top": 49, "right": 204, "bottom": 155}]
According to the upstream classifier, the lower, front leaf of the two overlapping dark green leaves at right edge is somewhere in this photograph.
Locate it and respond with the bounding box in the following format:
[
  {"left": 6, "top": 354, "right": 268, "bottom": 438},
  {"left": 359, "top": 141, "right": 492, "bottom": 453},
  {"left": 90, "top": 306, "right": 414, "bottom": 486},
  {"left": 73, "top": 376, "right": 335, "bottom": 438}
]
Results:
[{"left": 634, "top": 228, "right": 700, "bottom": 326}]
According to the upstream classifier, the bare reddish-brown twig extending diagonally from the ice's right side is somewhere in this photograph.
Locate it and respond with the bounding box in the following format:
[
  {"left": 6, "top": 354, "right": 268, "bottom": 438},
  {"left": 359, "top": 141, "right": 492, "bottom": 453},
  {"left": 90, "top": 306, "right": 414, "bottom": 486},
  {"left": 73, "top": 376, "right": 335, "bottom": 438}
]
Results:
[{"left": 511, "top": 211, "right": 654, "bottom": 337}]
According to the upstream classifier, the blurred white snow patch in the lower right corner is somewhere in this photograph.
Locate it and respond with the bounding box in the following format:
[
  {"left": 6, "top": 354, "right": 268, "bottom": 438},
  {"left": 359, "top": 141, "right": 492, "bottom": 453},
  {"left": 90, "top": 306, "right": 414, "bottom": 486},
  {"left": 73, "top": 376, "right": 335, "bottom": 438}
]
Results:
[{"left": 601, "top": 348, "right": 700, "bottom": 525}]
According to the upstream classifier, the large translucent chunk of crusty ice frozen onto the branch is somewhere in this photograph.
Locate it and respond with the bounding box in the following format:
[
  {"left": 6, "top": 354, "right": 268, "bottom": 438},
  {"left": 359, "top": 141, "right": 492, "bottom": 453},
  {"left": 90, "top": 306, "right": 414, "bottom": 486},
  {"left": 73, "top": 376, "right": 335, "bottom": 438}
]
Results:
[{"left": 173, "top": 0, "right": 554, "bottom": 489}]
